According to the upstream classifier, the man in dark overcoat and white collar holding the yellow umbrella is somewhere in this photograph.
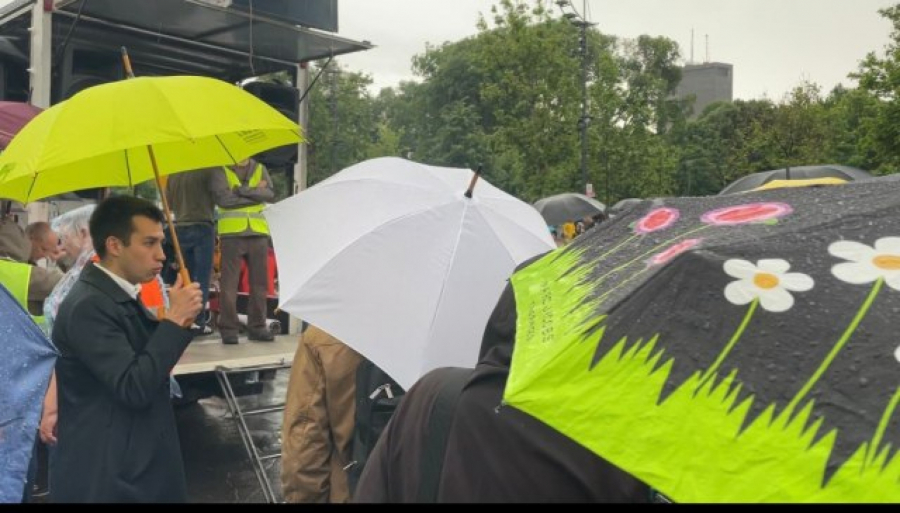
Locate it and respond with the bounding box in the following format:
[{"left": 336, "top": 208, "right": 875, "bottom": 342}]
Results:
[{"left": 50, "top": 197, "right": 202, "bottom": 502}]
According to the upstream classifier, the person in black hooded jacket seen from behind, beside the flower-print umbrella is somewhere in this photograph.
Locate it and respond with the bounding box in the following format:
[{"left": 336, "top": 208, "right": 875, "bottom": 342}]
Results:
[{"left": 354, "top": 270, "right": 650, "bottom": 502}]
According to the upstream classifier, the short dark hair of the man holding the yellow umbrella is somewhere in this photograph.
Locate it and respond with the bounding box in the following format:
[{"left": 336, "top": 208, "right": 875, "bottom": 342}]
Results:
[{"left": 90, "top": 196, "right": 165, "bottom": 258}]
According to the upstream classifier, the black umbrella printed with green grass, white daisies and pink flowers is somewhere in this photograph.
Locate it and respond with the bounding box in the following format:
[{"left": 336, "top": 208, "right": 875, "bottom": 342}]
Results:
[{"left": 505, "top": 177, "right": 900, "bottom": 502}]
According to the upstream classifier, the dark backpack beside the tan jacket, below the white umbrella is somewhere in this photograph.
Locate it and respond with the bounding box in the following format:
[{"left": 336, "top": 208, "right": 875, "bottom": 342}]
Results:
[{"left": 347, "top": 359, "right": 406, "bottom": 494}]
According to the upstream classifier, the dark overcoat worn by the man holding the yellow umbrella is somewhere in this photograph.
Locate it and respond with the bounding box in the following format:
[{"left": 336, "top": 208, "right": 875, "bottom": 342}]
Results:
[{"left": 50, "top": 264, "right": 191, "bottom": 502}]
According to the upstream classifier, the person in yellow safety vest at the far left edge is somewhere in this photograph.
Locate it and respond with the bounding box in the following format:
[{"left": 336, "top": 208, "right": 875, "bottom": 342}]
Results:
[{"left": 0, "top": 209, "right": 63, "bottom": 324}]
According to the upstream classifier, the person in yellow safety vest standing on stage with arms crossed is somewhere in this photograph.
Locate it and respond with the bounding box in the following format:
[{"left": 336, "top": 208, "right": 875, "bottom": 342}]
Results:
[{"left": 210, "top": 159, "right": 275, "bottom": 344}]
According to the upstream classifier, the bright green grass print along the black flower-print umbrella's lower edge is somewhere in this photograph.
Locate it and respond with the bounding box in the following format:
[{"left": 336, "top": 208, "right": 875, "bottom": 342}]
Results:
[{"left": 505, "top": 246, "right": 900, "bottom": 502}]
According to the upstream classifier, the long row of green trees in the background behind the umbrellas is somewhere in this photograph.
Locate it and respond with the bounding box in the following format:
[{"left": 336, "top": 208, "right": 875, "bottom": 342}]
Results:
[{"left": 309, "top": 0, "right": 900, "bottom": 202}]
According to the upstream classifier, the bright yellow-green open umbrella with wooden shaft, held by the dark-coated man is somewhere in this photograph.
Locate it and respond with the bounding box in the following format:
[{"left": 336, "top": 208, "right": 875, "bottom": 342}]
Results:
[{"left": 0, "top": 76, "right": 300, "bottom": 282}]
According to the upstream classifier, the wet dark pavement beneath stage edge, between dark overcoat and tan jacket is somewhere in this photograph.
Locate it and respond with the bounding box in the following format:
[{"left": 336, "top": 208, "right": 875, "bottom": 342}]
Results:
[{"left": 175, "top": 369, "right": 290, "bottom": 503}]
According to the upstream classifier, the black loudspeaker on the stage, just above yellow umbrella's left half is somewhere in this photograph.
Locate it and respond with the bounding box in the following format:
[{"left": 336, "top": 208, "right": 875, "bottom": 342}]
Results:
[{"left": 54, "top": 44, "right": 125, "bottom": 103}]
